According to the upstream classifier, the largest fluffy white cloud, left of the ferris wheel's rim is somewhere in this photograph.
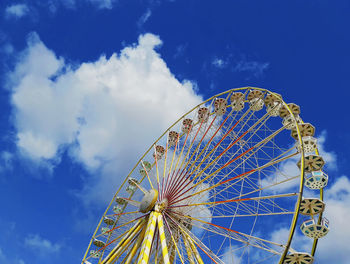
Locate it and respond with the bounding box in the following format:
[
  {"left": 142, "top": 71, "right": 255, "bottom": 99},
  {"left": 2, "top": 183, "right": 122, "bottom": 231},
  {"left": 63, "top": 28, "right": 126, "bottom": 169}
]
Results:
[{"left": 9, "top": 31, "right": 201, "bottom": 204}]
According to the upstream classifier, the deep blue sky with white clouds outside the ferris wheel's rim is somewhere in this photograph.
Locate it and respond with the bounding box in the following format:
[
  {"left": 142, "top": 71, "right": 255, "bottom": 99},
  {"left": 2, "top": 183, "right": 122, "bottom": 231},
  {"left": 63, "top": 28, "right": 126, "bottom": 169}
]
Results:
[{"left": 0, "top": 0, "right": 350, "bottom": 264}]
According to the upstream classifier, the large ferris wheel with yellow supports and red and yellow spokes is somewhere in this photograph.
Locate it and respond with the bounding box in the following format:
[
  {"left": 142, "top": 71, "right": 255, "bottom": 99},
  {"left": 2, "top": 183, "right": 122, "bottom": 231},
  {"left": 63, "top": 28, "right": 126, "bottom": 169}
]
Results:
[{"left": 82, "top": 87, "right": 329, "bottom": 264}]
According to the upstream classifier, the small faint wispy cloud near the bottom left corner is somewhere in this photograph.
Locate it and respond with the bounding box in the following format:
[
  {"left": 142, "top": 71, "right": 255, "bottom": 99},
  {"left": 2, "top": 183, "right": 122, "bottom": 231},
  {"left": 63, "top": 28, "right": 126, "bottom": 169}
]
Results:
[{"left": 24, "top": 234, "right": 61, "bottom": 255}]
